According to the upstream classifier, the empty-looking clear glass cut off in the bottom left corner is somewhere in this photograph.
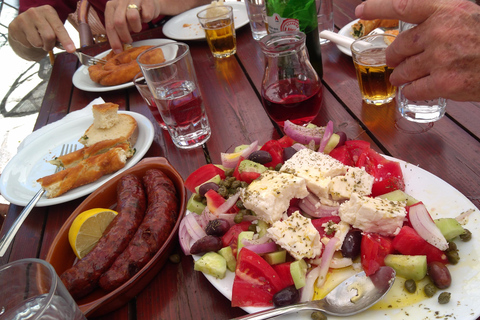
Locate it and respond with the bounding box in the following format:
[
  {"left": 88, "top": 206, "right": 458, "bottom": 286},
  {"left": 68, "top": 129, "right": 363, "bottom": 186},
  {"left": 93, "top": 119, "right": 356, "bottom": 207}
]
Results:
[{"left": 0, "top": 258, "right": 86, "bottom": 320}]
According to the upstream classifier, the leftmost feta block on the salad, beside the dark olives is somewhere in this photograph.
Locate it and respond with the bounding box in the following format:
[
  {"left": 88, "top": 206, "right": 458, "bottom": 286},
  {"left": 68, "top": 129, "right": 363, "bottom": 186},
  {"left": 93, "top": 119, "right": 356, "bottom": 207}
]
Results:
[{"left": 240, "top": 170, "right": 309, "bottom": 224}]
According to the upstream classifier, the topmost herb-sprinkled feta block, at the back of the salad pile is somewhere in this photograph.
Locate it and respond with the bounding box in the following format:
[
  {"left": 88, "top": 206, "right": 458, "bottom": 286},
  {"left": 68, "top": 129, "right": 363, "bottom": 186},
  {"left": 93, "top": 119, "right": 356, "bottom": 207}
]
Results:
[{"left": 280, "top": 148, "right": 347, "bottom": 198}]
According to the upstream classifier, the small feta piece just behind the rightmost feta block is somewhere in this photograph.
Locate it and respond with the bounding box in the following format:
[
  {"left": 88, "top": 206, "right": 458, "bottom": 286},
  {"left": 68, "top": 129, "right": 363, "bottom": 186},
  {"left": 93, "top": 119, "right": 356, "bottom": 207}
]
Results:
[{"left": 329, "top": 167, "right": 374, "bottom": 201}]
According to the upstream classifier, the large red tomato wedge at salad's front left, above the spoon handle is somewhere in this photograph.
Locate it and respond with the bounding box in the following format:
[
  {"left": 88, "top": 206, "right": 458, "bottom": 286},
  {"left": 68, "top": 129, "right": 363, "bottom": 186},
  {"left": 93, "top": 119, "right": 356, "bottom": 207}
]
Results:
[{"left": 232, "top": 248, "right": 283, "bottom": 307}]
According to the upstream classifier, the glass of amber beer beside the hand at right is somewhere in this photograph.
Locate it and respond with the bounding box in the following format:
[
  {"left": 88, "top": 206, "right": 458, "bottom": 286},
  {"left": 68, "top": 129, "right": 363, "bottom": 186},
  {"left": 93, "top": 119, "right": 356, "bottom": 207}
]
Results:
[{"left": 350, "top": 34, "right": 396, "bottom": 105}]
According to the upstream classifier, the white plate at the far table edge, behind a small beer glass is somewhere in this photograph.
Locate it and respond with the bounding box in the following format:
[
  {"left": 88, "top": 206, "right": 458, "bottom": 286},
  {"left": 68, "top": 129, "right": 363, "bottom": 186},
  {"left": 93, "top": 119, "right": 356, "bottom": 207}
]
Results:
[{"left": 163, "top": 2, "right": 249, "bottom": 40}]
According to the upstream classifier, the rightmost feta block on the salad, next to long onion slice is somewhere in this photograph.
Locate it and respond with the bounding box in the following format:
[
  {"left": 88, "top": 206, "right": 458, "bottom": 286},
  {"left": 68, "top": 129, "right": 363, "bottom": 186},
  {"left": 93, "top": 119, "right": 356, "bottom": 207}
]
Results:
[{"left": 338, "top": 193, "right": 407, "bottom": 236}]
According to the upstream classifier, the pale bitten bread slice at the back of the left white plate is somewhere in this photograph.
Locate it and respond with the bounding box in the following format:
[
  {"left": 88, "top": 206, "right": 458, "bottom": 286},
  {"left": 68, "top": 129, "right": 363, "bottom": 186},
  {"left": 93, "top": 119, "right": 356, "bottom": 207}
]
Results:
[{"left": 78, "top": 113, "right": 138, "bottom": 147}]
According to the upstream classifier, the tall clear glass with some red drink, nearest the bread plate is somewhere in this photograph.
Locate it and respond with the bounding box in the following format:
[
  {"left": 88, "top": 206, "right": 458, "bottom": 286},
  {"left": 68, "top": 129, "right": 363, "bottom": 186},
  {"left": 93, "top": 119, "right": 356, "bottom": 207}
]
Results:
[{"left": 137, "top": 42, "right": 211, "bottom": 149}]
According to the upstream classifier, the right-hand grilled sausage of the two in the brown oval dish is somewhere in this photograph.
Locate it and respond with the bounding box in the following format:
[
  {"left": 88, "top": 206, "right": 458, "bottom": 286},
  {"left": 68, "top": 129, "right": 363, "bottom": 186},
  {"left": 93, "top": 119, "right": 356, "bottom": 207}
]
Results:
[{"left": 99, "top": 169, "right": 178, "bottom": 291}]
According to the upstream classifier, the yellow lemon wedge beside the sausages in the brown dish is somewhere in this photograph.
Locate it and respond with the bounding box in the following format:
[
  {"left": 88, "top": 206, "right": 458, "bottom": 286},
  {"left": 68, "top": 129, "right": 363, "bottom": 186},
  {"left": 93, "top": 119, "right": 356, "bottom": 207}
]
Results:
[{"left": 68, "top": 208, "right": 117, "bottom": 259}]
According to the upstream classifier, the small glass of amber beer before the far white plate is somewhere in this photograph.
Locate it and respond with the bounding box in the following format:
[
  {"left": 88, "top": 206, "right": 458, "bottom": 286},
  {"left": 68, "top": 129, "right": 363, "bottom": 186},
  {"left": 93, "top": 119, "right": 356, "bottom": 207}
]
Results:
[{"left": 197, "top": 5, "right": 237, "bottom": 58}]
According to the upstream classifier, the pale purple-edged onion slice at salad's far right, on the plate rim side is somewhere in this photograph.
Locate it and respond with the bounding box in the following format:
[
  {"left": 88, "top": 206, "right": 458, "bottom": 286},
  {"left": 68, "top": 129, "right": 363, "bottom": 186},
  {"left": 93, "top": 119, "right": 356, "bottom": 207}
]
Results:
[{"left": 408, "top": 203, "right": 448, "bottom": 251}]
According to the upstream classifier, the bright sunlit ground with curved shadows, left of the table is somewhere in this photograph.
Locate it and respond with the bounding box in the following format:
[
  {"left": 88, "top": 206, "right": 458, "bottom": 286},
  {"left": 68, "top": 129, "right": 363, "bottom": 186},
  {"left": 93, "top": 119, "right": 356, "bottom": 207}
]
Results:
[{"left": 0, "top": 0, "right": 78, "bottom": 215}]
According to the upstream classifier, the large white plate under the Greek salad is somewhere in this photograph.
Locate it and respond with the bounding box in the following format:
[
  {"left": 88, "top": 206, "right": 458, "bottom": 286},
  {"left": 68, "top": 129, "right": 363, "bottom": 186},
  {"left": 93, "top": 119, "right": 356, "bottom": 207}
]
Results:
[{"left": 193, "top": 157, "right": 480, "bottom": 320}]
